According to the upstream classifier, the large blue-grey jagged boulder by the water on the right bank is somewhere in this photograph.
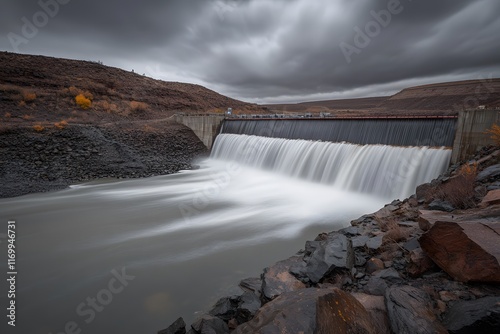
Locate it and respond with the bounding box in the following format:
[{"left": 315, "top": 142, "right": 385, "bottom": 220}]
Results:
[{"left": 291, "top": 233, "right": 355, "bottom": 284}]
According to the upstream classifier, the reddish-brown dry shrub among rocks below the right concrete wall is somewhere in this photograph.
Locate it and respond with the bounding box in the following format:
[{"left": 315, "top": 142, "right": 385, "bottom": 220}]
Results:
[{"left": 436, "top": 163, "right": 477, "bottom": 209}]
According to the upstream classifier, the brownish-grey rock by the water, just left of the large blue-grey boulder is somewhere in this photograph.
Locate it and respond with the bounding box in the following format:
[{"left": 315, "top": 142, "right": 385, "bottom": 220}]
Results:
[{"left": 262, "top": 256, "right": 306, "bottom": 299}]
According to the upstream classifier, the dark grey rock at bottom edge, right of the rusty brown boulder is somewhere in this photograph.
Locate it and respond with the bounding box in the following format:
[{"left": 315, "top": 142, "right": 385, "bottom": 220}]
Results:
[{"left": 385, "top": 286, "right": 447, "bottom": 334}]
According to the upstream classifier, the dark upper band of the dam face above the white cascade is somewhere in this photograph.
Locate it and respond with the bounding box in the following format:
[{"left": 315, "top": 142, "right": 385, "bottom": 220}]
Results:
[{"left": 222, "top": 118, "right": 456, "bottom": 147}]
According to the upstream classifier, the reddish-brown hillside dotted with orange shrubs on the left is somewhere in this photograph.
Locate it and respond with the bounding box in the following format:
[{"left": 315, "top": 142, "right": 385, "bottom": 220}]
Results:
[{"left": 0, "top": 52, "right": 260, "bottom": 123}]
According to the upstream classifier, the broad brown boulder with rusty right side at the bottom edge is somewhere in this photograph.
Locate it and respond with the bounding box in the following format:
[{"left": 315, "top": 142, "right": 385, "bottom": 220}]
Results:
[{"left": 233, "top": 288, "right": 375, "bottom": 334}]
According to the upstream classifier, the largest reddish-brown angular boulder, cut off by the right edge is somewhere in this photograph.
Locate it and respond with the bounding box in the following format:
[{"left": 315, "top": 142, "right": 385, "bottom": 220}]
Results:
[{"left": 419, "top": 221, "right": 500, "bottom": 283}]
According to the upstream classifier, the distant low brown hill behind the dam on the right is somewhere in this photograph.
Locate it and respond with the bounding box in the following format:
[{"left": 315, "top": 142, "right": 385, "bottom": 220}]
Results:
[{"left": 265, "top": 79, "right": 500, "bottom": 116}]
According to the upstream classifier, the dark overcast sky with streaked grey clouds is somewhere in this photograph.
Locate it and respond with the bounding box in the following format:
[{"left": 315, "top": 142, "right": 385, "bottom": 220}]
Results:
[{"left": 0, "top": 0, "right": 500, "bottom": 103}]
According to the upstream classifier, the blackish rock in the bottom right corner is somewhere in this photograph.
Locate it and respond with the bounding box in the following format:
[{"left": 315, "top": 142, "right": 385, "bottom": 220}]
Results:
[{"left": 443, "top": 296, "right": 500, "bottom": 334}]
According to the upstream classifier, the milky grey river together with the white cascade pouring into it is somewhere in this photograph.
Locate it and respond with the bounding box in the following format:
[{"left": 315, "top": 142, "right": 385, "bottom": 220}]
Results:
[{"left": 0, "top": 118, "right": 450, "bottom": 333}]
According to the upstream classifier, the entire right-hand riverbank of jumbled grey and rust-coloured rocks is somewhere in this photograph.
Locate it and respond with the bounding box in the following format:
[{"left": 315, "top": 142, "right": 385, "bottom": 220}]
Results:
[{"left": 159, "top": 147, "right": 500, "bottom": 334}]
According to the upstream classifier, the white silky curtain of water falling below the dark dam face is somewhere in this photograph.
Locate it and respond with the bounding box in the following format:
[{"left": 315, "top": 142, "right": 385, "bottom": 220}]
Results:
[{"left": 211, "top": 134, "right": 451, "bottom": 200}]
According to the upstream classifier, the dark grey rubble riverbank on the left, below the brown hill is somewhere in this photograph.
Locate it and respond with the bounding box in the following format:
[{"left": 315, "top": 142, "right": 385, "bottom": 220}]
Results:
[{"left": 0, "top": 120, "right": 208, "bottom": 197}]
